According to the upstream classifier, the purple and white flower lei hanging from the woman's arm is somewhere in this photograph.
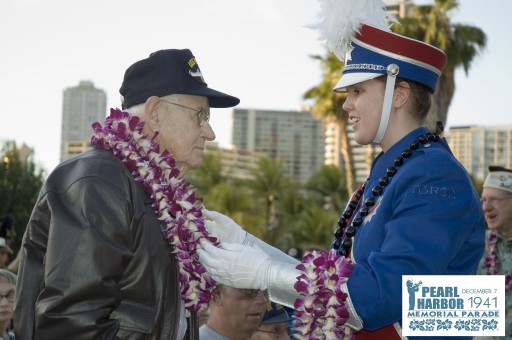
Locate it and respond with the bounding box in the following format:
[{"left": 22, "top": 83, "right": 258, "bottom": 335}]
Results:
[{"left": 294, "top": 249, "right": 353, "bottom": 339}]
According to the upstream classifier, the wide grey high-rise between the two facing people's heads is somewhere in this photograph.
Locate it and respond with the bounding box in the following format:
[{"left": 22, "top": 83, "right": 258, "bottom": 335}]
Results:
[{"left": 233, "top": 109, "right": 324, "bottom": 183}]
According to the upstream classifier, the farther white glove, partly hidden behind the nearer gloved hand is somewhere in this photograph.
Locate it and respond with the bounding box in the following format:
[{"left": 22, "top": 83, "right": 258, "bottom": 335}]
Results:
[{"left": 203, "top": 208, "right": 247, "bottom": 244}]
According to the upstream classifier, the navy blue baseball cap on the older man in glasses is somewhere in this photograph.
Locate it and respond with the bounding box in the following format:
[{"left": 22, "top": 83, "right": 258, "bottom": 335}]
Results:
[{"left": 119, "top": 49, "right": 240, "bottom": 109}]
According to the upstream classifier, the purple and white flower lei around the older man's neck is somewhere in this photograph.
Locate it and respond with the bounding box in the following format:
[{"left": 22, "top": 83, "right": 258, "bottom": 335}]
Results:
[{"left": 91, "top": 109, "right": 219, "bottom": 316}]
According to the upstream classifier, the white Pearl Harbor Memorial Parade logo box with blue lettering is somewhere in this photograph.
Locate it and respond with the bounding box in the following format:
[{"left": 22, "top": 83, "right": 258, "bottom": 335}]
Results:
[{"left": 402, "top": 275, "right": 505, "bottom": 336}]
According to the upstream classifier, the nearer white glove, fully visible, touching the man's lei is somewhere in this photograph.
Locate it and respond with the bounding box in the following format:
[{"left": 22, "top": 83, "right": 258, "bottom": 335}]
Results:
[{"left": 197, "top": 240, "right": 271, "bottom": 290}]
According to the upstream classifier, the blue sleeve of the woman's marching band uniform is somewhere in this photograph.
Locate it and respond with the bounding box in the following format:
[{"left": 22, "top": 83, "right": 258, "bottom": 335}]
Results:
[{"left": 347, "top": 158, "right": 485, "bottom": 330}]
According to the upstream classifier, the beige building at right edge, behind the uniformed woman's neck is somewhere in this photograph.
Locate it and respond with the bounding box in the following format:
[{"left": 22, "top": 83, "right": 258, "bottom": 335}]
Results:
[{"left": 445, "top": 126, "right": 512, "bottom": 181}]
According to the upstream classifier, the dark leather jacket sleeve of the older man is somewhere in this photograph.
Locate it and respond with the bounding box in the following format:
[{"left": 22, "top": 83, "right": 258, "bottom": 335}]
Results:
[{"left": 21, "top": 177, "right": 132, "bottom": 339}]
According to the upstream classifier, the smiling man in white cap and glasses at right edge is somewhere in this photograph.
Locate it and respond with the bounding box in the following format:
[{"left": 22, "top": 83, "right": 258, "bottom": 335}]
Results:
[{"left": 476, "top": 166, "right": 512, "bottom": 339}]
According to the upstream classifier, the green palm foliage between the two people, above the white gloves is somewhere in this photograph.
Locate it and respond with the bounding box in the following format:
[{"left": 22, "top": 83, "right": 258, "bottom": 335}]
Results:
[{"left": 187, "top": 154, "right": 346, "bottom": 250}]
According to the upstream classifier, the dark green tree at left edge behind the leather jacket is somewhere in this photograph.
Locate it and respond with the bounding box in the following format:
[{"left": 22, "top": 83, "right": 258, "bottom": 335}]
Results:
[{"left": 0, "top": 141, "right": 44, "bottom": 250}]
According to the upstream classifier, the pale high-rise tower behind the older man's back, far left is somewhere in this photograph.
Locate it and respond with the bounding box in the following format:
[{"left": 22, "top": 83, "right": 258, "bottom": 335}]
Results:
[{"left": 60, "top": 80, "right": 107, "bottom": 161}]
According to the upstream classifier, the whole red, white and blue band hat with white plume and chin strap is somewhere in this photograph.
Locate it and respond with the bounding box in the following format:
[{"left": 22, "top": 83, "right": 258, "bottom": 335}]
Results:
[{"left": 311, "top": 0, "right": 446, "bottom": 144}]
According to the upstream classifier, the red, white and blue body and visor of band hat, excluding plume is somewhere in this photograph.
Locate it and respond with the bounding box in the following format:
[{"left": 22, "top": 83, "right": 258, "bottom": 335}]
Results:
[{"left": 334, "top": 24, "right": 446, "bottom": 92}]
